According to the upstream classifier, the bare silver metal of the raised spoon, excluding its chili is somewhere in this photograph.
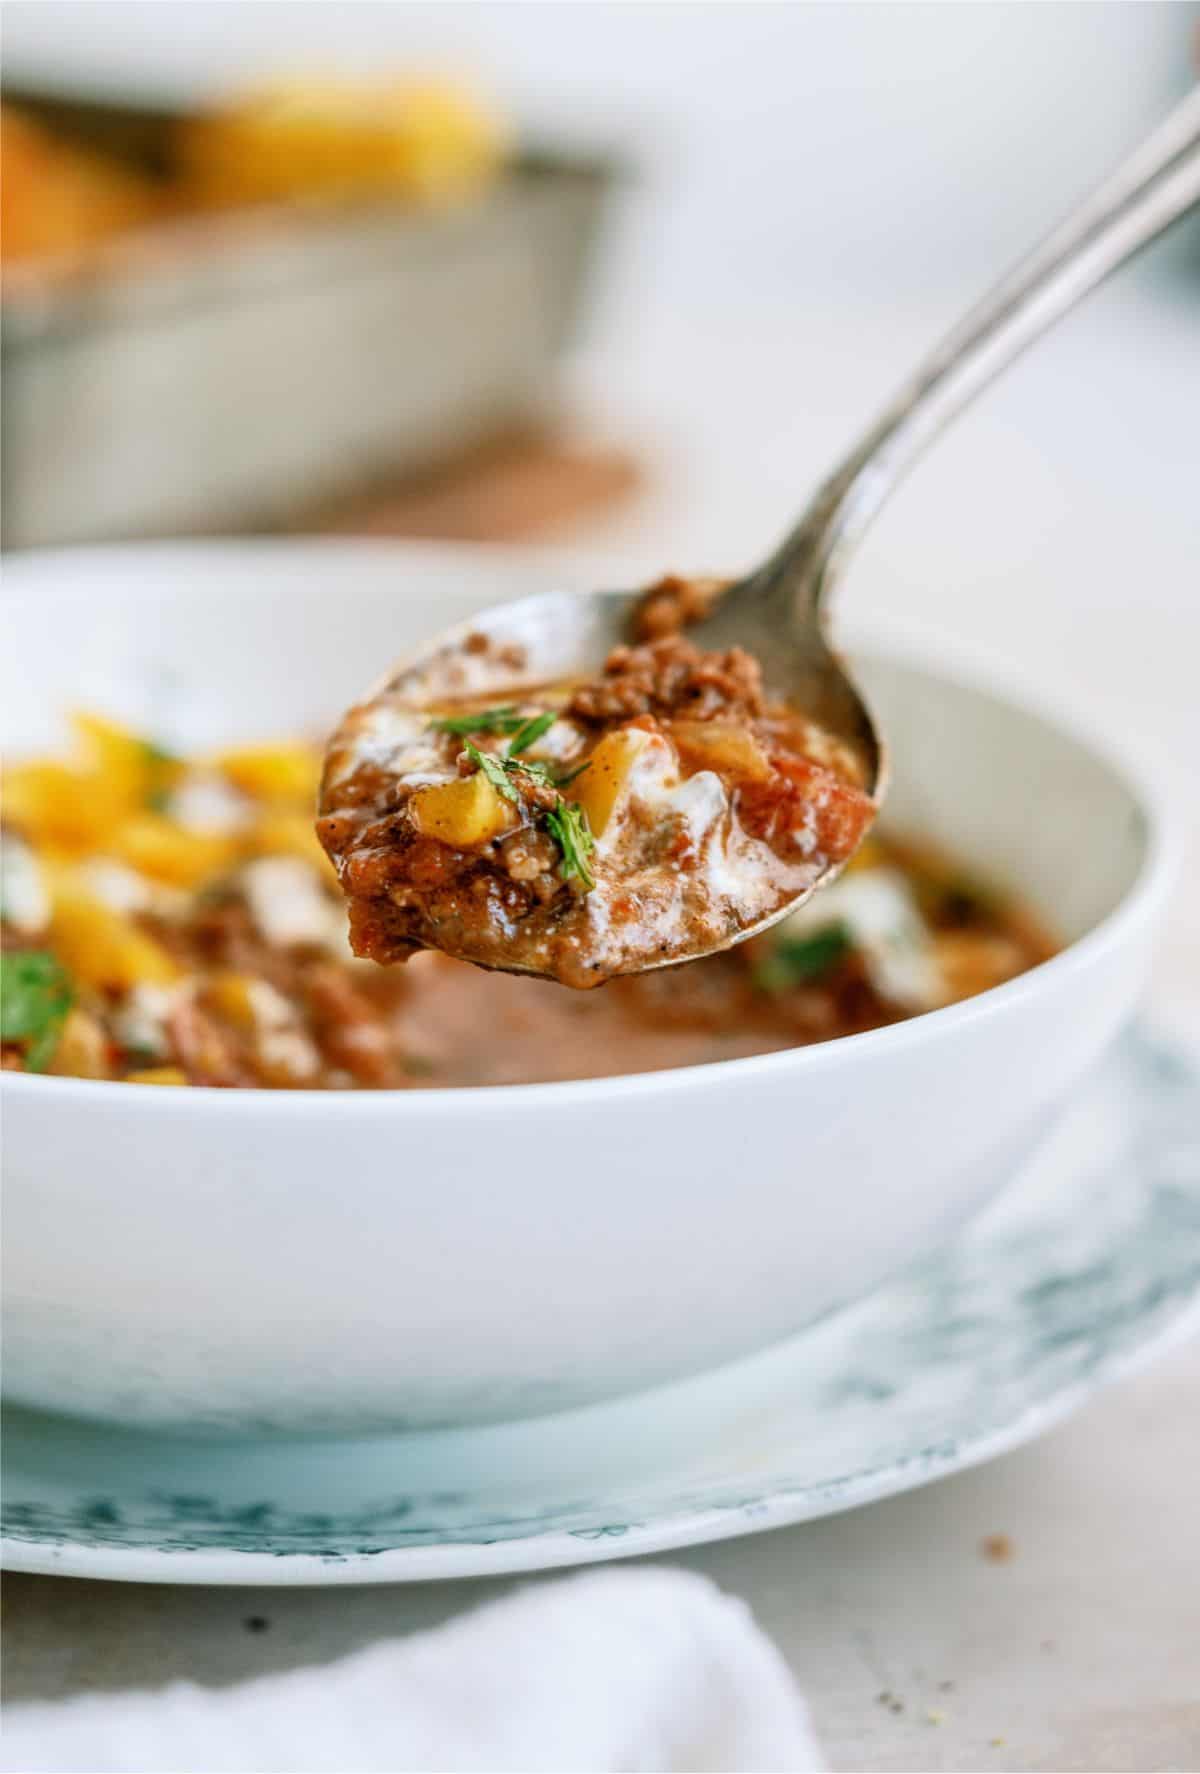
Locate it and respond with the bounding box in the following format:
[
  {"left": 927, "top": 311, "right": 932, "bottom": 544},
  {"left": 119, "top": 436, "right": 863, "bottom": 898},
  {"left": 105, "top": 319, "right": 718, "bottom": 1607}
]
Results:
[{"left": 337, "top": 87, "right": 1200, "bottom": 972}]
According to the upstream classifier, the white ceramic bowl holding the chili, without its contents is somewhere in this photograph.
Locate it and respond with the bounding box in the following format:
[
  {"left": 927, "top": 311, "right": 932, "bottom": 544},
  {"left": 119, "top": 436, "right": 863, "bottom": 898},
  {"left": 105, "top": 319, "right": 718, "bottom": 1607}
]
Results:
[{"left": 0, "top": 545, "right": 1168, "bottom": 1430}]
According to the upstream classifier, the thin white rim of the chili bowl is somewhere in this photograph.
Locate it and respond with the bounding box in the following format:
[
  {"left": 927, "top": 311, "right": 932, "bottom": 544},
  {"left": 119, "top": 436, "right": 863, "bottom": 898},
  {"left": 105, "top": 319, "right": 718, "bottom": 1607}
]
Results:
[{"left": 0, "top": 538, "right": 1182, "bottom": 1118}]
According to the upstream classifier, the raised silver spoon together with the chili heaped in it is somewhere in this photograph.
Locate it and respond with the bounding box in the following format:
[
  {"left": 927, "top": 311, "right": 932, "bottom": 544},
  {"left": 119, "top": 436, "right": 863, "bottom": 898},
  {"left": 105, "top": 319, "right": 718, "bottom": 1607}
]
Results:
[{"left": 318, "top": 89, "right": 1200, "bottom": 986}]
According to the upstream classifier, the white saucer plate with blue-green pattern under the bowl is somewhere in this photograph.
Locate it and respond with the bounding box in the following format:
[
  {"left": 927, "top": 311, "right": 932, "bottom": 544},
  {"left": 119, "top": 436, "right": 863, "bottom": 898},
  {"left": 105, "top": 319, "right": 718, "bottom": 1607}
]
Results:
[{"left": 2, "top": 1031, "right": 1200, "bottom": 1584}]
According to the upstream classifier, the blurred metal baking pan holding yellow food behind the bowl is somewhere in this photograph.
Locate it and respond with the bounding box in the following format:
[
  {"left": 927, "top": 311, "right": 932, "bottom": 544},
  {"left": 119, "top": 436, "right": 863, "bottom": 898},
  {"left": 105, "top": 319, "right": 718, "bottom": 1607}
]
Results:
[{"left": 0, "top": 90, "right": 614, "bottom": 548}]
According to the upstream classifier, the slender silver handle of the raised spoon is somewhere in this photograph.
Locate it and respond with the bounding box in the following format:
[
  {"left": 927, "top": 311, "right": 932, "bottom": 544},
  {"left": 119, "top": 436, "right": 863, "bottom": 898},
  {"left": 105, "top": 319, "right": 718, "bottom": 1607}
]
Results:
[{"left": 747, "top": 87, "right": 1200, "bottom": 614}]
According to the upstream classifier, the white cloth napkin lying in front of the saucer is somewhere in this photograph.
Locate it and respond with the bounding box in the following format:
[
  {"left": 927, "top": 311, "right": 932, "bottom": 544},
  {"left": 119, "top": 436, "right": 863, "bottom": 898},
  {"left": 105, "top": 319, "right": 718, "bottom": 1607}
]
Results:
[{"left": 0, "top": 1566, "right": 824, "bottom": 1774}]
